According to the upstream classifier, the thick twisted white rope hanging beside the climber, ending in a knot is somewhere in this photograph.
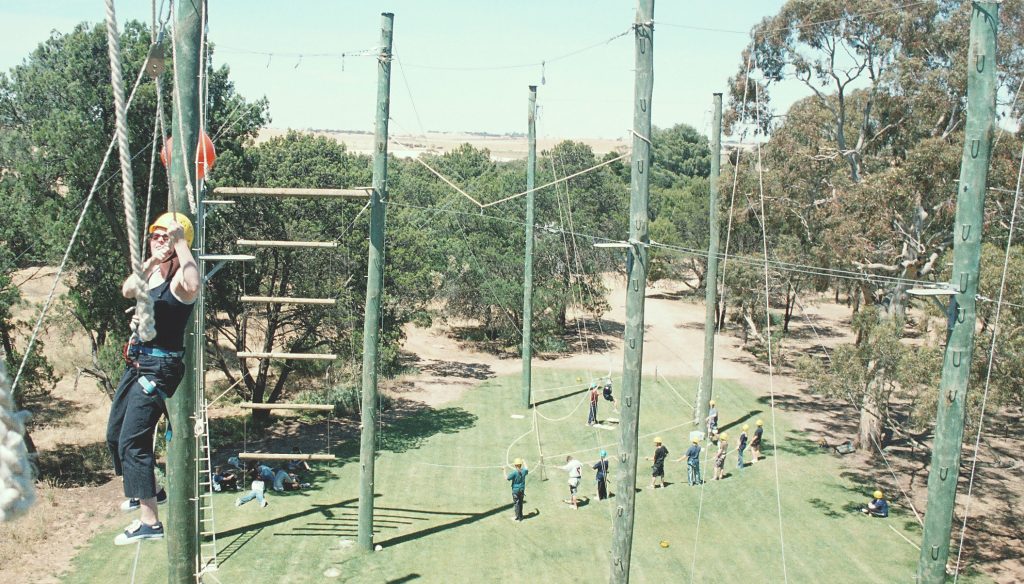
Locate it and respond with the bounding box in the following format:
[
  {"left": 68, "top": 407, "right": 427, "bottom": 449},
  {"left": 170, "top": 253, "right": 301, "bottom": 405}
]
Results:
[{"left": 106, "top": 0, "right": 157, "bottom": 341}]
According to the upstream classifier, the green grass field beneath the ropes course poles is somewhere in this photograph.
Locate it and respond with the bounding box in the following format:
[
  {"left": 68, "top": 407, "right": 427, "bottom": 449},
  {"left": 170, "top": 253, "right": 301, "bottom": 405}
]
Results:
[{"left": 63, "top": 368, "right": 988, "bottom": 584}]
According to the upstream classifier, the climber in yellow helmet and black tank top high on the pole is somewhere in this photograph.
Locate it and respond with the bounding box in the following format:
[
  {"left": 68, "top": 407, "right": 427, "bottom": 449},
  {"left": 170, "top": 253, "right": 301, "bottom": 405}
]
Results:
[{"left": 106, "top": 213, "right": 200, "bottom": 545}]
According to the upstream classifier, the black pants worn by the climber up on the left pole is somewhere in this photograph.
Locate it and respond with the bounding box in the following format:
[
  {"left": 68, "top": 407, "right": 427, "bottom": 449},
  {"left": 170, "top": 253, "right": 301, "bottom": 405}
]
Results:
[{"left": 106, "top": 354, "right": 184, "bottom": 499}]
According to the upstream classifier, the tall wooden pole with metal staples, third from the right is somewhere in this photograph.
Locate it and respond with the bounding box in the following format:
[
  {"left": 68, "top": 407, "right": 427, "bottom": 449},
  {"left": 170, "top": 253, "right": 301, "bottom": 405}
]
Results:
[{"left": 609, "top": 0, "right": 654, "bottom": 583}]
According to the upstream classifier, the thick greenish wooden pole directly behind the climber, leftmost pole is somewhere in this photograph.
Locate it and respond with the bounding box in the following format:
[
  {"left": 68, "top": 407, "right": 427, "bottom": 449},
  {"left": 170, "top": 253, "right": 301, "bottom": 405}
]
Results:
[{"left": 166, "top": 2, "right": 203, "bottom": 584}]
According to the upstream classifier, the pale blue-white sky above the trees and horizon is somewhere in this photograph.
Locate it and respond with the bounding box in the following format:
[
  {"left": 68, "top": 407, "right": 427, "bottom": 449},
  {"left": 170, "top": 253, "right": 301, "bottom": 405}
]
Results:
[{"left": 0, "top": 0, "right": 800, "bottom": 139}]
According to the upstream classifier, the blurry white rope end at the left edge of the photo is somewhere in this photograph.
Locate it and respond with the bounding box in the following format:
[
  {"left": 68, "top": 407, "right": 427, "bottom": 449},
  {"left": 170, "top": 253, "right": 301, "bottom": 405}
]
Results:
[{"left": 0, "top": 360, "right": 36, "bottom": 523}]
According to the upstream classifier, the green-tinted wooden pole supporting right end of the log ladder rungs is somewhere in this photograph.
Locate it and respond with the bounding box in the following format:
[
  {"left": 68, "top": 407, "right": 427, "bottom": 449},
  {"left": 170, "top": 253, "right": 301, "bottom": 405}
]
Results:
[{"left": 357, "top": 12, "right": 394, "bottom": 551}]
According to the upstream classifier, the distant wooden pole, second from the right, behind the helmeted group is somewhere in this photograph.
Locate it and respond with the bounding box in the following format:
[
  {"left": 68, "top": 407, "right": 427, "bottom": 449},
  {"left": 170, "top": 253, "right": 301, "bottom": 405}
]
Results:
[{"left": 694, "top": 93, "right": 722, "bottom": 425}]
